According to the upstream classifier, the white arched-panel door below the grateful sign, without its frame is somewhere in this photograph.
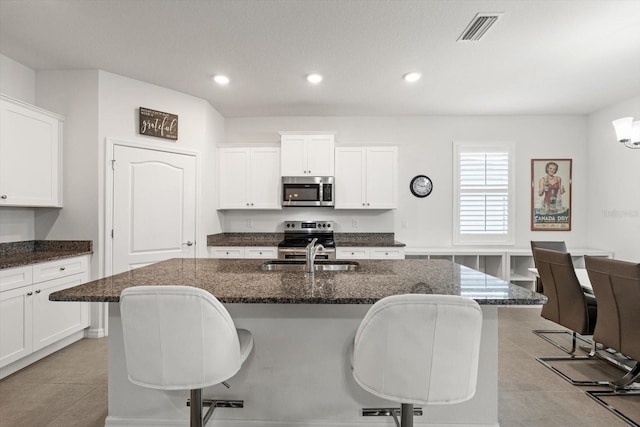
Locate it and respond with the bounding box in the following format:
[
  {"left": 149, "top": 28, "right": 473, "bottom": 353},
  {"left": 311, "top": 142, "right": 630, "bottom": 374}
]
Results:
[{"left": 112, "top": 145, "right": 196, "bottom": 274}]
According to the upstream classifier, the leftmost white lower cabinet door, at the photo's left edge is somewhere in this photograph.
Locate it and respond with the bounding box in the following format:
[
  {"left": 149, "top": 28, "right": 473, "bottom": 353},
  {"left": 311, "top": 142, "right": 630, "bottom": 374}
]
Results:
[{"left": 0, "top": 286, "right": 34, "bottom": 367}]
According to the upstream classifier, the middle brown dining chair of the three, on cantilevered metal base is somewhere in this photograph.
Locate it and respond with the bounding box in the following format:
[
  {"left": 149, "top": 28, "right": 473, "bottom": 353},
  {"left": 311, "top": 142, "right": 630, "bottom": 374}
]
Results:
[{"left": 533, "top": 248, "right": 608, "bottom": 385}]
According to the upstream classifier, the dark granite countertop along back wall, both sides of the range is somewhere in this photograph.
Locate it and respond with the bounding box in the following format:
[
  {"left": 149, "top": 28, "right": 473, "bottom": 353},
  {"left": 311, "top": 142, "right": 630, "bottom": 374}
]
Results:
[{"left": 207, "top": 232, "right": 405, "bottom": 248}]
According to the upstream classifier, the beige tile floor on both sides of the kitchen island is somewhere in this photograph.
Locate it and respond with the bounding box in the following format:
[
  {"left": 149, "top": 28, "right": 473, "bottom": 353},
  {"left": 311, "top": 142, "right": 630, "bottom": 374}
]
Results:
[{"left": 0, "top": 307, "right": 640, "bottom": 427}]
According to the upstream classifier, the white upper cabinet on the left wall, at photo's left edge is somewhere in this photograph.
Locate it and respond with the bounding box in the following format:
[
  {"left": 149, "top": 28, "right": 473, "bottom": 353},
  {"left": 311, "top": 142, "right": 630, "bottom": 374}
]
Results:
[{"left": 0, "top": 95, "right": 63, "bottom": 207}]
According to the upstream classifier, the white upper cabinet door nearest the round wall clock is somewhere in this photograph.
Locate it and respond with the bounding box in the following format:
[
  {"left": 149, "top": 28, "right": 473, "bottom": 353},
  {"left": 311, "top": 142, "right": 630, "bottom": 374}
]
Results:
[{"left": 366, "top": 147, "right": 398, "bottom": 209}]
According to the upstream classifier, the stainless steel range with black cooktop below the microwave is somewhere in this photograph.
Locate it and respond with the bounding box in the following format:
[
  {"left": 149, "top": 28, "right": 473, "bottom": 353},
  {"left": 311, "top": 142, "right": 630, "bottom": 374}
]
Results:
[{"left": 278, "top": 221, "right": 336, "bottom": 259}]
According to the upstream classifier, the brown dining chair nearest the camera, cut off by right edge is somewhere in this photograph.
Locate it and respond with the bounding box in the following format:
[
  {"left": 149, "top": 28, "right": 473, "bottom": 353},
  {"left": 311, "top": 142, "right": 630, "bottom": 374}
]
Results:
[{"left": 585, "top": 256, "right": 640, "bottom": 426}]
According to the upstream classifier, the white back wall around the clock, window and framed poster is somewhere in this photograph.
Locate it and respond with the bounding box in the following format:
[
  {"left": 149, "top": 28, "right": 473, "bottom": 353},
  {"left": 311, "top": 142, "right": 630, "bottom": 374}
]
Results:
[{"left": 222, "top": 116, "right": 592, "bottom": 249}]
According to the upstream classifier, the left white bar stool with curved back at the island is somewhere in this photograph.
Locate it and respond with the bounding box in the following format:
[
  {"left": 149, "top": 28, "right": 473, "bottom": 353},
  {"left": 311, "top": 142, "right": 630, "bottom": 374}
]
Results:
[{"left": 120, "top": 286, "right": 253, "bottom": 427}]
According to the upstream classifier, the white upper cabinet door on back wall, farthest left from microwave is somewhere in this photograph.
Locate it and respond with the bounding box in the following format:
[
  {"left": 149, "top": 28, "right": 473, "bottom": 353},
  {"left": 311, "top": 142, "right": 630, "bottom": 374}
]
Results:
[{"left": 218, "top": 147, "right": 250, "bottom": 209}]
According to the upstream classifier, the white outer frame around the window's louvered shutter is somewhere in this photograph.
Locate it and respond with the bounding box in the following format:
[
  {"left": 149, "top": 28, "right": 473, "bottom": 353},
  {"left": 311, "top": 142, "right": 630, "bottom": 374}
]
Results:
[{"left": 452, "top": 141, "right": 516, "bottom": 245}]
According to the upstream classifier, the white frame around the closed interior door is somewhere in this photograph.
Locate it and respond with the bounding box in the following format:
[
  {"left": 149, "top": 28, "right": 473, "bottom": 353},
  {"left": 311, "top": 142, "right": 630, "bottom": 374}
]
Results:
[{"left": 104, "top": 138, "right": 202, "bottom": 277}]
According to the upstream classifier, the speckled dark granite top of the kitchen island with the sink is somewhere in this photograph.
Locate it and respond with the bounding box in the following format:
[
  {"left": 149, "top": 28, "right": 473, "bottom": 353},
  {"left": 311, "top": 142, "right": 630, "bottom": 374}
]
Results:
[{"left": 49, "top": 258, "right": 546, "bottom": 305}]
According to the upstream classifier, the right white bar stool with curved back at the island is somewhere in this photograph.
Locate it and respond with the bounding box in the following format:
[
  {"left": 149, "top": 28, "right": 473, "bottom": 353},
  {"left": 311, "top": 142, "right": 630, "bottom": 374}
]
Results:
[{"left": 351, "top": 294, "right": 482, "bottom": 427}]
